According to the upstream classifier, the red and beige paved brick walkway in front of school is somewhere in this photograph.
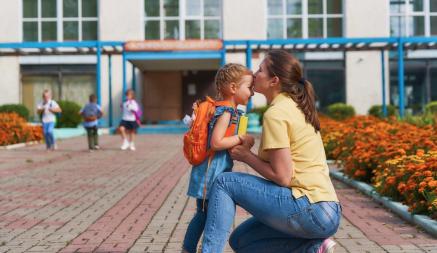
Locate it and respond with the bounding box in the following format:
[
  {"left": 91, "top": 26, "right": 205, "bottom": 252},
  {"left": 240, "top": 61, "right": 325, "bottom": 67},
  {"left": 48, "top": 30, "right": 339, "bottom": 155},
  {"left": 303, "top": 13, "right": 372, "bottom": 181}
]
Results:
[{"left": 0, "top": 135, "right": 437, "bottom": 253}]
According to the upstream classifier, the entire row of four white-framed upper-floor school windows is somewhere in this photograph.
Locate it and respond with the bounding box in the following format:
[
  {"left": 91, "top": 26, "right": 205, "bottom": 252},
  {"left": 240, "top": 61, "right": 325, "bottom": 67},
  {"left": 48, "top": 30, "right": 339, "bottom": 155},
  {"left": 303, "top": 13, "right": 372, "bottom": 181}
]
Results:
[{"left": 22, "top": 0, "right": 437, "bottom": 41}]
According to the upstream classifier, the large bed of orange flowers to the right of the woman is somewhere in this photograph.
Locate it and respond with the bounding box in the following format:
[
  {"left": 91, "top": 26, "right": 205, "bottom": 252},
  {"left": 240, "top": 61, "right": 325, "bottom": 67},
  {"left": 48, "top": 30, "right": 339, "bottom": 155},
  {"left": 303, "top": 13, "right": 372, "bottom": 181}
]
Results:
[{"left": 321, "top": 116, "right": 437, "bottom": 218}]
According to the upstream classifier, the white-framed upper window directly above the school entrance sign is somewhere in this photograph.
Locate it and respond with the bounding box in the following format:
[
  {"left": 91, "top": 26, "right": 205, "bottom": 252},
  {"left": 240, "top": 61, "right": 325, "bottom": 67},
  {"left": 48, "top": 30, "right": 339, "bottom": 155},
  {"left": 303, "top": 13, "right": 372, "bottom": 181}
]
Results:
[{"left": 144, "top": 0, "right": 221, "bottom": 40}]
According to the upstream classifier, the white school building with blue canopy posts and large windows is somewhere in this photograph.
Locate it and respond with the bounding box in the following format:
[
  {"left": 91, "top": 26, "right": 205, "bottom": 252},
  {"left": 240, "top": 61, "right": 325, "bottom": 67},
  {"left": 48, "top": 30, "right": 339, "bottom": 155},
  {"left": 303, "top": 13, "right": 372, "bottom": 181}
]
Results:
[{"left": 0, "top": 0, "right": 437, "bottom": 125}]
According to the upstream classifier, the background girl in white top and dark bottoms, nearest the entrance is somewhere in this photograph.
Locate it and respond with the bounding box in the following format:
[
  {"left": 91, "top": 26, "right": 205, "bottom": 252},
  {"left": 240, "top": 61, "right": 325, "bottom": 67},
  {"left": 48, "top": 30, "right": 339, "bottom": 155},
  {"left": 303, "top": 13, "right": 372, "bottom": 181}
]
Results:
[{"left": 120, "top": 89, "right": 140, "bottom": 151}]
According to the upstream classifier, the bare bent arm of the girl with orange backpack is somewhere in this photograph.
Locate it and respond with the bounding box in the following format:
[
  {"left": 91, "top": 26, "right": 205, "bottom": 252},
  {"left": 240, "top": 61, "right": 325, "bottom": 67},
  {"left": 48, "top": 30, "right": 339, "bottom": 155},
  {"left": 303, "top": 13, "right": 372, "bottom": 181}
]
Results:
[{"left": 211, "top": 112, "right": 241, "bottom": 151}]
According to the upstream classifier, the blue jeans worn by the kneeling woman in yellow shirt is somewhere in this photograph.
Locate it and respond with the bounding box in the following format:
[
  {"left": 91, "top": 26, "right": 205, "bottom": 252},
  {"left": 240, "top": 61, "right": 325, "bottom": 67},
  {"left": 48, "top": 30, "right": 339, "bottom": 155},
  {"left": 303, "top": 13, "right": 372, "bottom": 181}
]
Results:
[{"left": 202, "top": 172, "right": 341, "bottom": 253}]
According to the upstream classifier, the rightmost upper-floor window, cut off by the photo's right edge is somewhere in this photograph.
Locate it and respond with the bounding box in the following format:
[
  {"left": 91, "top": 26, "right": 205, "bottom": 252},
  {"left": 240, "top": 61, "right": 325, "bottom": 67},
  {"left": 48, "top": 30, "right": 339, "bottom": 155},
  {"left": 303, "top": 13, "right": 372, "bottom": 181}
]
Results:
[{"left": 390, "top": 0, "right": 437, "bottom": 37}]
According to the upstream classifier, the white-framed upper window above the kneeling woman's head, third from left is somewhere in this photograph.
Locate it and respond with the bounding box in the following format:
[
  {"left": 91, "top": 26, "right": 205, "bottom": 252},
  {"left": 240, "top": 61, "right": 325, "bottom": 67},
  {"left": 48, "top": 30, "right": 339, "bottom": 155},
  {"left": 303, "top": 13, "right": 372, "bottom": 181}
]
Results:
[{"left": 267, "top": 0, "right": 343, "bottom": 39}]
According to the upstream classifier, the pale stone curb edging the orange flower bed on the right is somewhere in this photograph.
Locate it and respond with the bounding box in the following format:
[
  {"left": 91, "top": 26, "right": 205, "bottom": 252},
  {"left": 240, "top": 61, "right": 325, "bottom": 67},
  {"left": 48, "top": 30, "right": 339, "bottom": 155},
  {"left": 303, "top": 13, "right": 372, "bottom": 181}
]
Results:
[{"left": 330, "top": 171, "right": 437, "bottom": 238}]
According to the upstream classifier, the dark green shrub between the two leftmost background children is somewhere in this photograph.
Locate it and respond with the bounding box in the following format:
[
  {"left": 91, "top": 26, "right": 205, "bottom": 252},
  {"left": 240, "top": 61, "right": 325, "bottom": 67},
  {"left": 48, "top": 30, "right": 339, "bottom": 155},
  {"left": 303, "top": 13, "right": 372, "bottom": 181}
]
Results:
[{"left": 56, "top": 100, "right": 82, "bottom": 128}]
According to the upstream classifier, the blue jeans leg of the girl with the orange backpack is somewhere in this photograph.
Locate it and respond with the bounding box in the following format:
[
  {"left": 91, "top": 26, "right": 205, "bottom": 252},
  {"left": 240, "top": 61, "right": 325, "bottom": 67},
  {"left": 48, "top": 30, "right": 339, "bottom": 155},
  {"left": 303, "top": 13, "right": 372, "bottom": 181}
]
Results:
[{"left": 183, "top": 199, "right": 208, "bottom": 253}]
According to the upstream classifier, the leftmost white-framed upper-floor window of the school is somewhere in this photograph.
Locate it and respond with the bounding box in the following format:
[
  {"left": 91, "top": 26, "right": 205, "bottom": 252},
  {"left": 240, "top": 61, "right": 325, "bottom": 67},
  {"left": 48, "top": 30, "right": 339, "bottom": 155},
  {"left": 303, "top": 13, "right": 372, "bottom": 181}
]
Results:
[{"left": 23, "top": 0, "right": 98, "bottom": 41}]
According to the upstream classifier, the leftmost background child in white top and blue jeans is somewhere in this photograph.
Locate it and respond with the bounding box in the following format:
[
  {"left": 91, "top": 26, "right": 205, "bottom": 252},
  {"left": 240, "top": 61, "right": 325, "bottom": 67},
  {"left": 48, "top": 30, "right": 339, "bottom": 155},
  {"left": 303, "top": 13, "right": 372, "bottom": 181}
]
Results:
[{"left": 37, "top": 90, "right": 62, "bottom": 150}]
